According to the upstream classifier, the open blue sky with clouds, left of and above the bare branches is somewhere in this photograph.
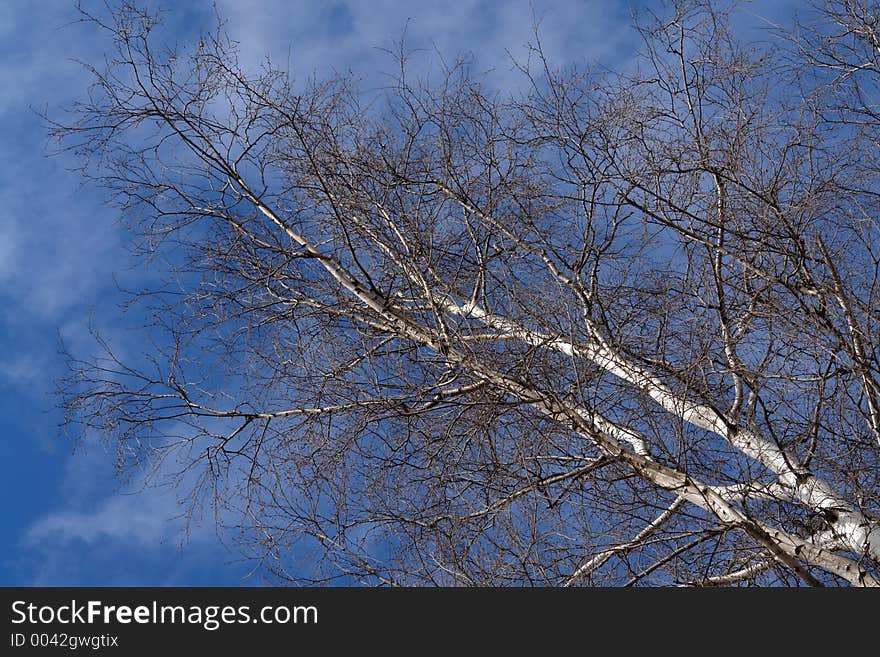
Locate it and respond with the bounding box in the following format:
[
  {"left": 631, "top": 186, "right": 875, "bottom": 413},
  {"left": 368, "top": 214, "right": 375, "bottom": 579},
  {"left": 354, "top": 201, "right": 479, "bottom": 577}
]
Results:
[{"left": 0, "top": 0, "right": 794, "bottom": 585}]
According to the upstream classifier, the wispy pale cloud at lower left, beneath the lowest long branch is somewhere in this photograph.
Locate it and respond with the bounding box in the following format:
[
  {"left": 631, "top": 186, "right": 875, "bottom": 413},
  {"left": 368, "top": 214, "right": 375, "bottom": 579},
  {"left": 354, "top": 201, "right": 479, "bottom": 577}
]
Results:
[{"left": 20, "top": 430, "right": 248, "bottom": 586}]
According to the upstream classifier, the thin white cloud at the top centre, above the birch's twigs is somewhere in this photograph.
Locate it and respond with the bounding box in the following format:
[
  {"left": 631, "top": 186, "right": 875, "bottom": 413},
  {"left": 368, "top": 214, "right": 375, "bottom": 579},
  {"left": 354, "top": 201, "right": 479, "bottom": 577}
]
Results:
[{"left": 212, "top": 0, "right": 629, "bottom": 84}]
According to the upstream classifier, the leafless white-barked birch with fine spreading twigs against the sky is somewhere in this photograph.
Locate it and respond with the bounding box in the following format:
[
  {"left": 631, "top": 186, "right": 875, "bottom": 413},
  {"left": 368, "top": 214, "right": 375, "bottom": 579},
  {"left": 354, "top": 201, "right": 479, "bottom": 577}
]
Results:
[{"left": 53, "top": 1, "right": 880, "bottom": 586}]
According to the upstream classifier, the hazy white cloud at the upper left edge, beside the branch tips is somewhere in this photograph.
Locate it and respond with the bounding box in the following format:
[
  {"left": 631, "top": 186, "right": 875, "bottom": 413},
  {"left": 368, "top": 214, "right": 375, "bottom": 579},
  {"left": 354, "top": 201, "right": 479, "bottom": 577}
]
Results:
[{"left": 0, "top": 2, "right": 120, "bottom": 324}]
